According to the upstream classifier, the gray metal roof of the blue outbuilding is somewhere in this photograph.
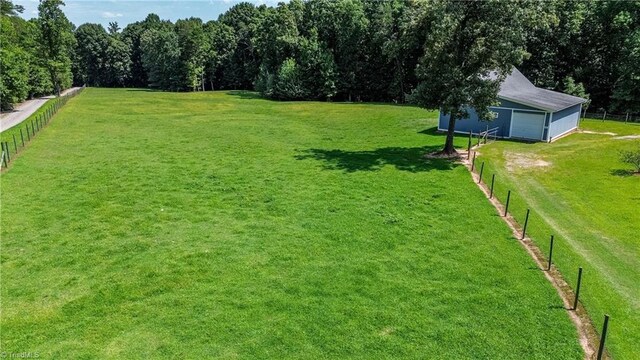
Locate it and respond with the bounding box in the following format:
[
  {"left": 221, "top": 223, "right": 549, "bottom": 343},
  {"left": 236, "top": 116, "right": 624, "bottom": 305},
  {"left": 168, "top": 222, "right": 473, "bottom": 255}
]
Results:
[{"left": 490, "top": 68, "right": 587, "bottom": 112}]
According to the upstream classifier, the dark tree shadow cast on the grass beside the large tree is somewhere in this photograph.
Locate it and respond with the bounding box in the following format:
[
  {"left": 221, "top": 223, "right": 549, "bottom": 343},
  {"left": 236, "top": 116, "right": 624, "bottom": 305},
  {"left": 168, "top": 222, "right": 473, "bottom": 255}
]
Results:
[{"left": 296, "top": 145, "right": 460, "bottom": 172}]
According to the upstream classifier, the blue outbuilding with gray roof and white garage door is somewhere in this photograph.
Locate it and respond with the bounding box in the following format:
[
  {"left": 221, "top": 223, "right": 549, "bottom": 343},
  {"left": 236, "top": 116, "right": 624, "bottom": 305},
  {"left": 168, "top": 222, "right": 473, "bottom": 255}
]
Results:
[{"left": 438, "top": 68, "right": 587, "bottom": 142}]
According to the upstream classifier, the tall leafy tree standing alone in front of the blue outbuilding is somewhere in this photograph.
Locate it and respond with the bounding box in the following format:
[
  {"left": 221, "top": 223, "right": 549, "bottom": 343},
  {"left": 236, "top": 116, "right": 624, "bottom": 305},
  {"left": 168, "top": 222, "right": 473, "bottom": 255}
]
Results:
[{"left": 413, "top": 0, "right": 541, "bottom": 155}]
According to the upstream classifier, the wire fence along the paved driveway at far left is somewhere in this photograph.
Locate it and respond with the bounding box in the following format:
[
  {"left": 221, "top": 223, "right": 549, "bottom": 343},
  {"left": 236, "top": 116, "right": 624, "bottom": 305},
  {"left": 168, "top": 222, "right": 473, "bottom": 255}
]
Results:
[{"left": 0, "top": 87, "right": 84, "bottom": 170}]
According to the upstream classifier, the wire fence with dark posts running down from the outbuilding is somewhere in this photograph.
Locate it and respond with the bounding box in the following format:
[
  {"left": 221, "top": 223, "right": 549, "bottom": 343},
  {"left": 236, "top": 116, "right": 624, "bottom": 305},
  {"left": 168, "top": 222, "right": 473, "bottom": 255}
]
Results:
[{"left": 467, "top": 147, "right": 609, "bottom": 360}]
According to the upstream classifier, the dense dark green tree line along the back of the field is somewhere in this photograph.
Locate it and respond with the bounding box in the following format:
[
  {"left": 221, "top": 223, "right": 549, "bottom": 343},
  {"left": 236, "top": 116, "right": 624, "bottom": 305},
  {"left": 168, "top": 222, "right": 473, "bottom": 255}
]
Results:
[{"left": 0, "top": 0, "right": 640, "bottom": 113}]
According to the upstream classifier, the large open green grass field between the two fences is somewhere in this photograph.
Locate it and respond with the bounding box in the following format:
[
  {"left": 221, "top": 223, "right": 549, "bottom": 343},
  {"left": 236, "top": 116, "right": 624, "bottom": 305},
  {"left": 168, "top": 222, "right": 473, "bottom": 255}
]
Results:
[{"left": 0, "top": 89, "right": 584, "bottom": 359}]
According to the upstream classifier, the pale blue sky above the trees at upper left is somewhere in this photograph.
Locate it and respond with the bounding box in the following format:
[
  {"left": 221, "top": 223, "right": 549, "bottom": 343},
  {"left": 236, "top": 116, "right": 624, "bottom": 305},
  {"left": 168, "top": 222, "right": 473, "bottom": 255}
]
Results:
[{"left": 13, "top": 0, "right": 278, "bottom": 28}]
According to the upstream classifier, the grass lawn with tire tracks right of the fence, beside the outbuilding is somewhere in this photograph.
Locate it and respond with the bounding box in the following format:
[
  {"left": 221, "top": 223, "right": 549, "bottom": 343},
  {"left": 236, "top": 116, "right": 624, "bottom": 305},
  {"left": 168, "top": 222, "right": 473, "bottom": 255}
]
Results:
[{"left": 479, "top": 120, "right": 640, "bottom": 359}]
